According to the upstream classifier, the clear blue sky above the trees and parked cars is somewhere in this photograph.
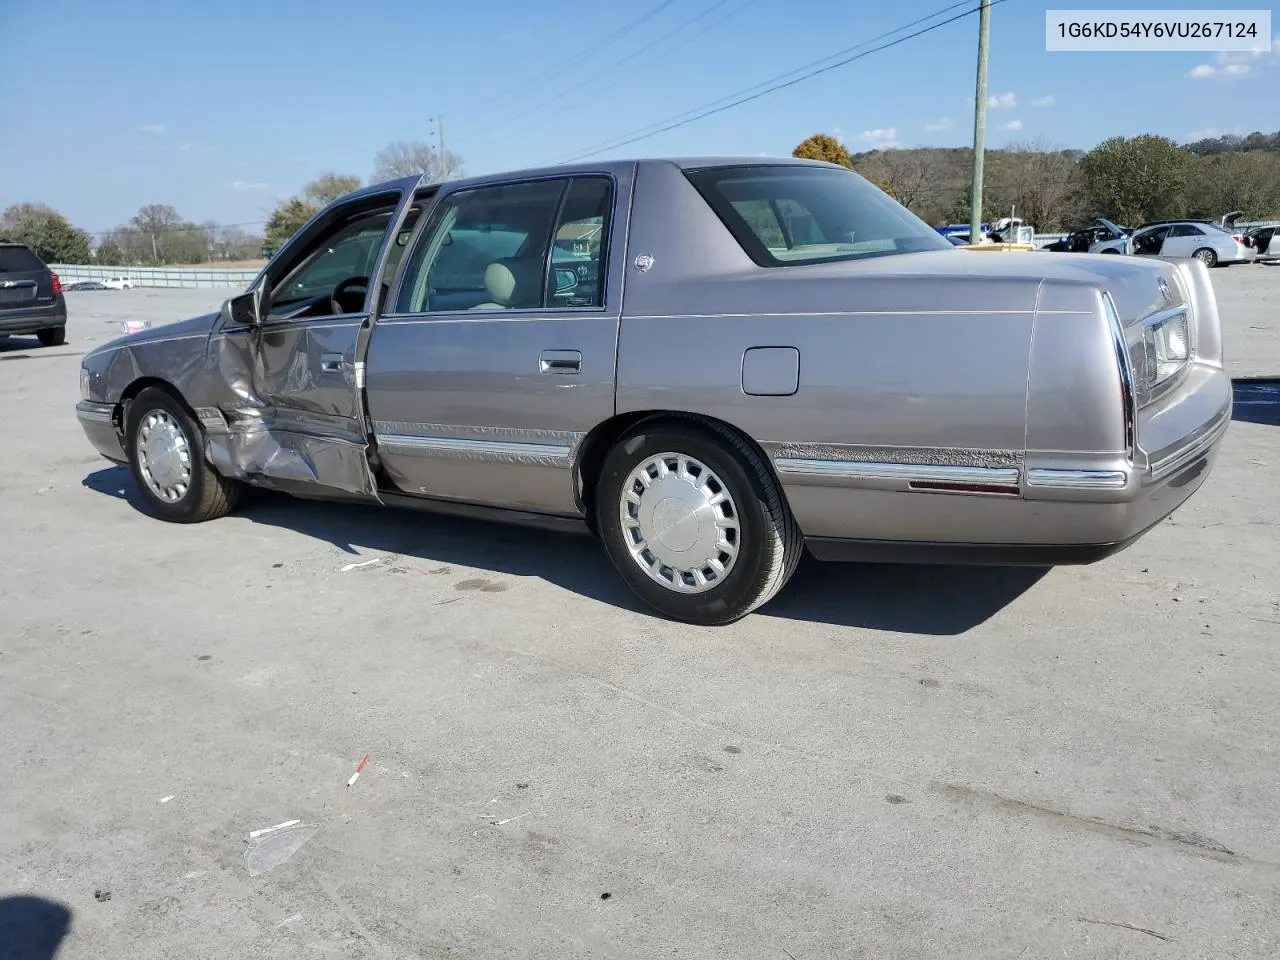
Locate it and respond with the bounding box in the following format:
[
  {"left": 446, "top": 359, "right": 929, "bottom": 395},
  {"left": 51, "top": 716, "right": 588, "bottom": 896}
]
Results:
[{"left": 0, "top": 0, "right": 1280, "bottom": 238}]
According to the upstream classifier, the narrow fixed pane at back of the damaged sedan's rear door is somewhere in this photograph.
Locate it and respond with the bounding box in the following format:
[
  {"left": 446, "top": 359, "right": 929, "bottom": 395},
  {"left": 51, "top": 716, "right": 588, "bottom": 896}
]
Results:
[{"left": 545, "top": 177, "right": 613, "bottom": 307}]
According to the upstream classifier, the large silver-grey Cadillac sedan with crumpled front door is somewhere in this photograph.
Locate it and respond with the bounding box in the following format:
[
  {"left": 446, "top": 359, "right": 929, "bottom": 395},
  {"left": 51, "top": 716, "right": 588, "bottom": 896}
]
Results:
[{"left": 77, "top": 159, "right": 1231, "bottom": 623}]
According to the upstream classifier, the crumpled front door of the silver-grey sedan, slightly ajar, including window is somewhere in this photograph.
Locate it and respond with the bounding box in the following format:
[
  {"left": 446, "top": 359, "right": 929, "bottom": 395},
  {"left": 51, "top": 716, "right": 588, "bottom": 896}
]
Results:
[{"left": 206, "top": 191, "right": 404, "bottom": 498}]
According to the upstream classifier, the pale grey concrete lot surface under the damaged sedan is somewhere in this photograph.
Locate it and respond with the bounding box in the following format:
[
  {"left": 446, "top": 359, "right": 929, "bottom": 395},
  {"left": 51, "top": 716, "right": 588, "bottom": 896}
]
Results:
[{"left": 0, "top": 266, "right": 1280, "bottom": 960}]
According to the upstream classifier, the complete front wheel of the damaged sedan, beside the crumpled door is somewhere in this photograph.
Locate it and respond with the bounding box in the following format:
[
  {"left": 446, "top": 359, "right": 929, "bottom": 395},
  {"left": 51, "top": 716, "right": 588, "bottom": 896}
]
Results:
[{"left": 125, "top": 387, "right": 239, "bottom": 524}]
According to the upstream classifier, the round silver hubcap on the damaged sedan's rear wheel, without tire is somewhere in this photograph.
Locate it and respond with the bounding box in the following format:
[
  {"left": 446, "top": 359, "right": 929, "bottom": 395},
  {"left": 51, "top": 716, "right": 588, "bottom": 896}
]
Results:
[{"left": 618, "top": 453, "right": 741, "bottom": 594}]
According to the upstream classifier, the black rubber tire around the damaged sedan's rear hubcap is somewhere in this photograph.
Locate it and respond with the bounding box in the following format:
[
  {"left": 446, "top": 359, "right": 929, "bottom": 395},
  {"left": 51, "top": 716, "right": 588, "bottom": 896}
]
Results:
[{"left": 595, "top": 419, "right": 804, "bottom": 626}]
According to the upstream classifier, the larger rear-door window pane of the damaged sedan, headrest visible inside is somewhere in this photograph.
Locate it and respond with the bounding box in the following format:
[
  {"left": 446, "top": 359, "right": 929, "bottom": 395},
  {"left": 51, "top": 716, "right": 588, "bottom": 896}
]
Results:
[{"left": 396, "top": 179, "right": 566, "bottom": 314}]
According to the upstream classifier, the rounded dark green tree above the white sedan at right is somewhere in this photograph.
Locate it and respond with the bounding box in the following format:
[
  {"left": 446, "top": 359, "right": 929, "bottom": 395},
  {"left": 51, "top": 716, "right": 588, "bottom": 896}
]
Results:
[{"left": 1080, "top": 134, "right": 1192, "bottom": 224}]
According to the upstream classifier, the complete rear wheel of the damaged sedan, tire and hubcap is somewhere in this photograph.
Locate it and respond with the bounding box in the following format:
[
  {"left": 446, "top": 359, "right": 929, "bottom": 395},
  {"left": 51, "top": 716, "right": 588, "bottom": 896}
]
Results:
[{"left": 595, "top": 420, "right": 804, "bottom": 626}]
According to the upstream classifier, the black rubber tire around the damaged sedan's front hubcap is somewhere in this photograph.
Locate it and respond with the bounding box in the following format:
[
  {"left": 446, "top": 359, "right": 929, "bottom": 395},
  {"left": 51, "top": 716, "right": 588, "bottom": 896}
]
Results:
[{"left": 124, "top": 387, "right": 241, "bottom": 524}]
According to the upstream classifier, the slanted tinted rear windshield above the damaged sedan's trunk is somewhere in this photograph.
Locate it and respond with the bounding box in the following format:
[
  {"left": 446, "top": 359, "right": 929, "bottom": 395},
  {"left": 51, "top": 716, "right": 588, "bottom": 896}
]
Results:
[{"left": 686, "top": 165, "right": 952, "bottom": 266}]
